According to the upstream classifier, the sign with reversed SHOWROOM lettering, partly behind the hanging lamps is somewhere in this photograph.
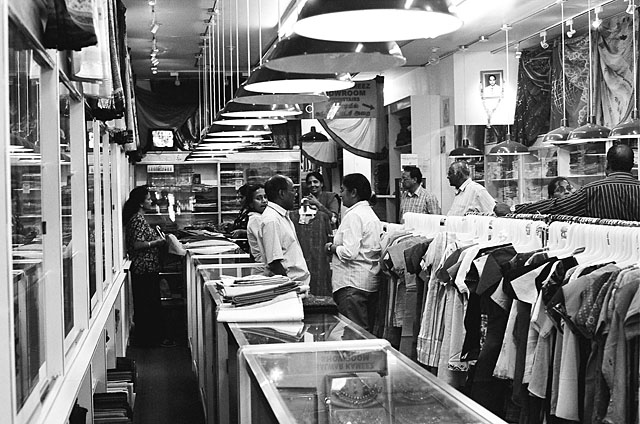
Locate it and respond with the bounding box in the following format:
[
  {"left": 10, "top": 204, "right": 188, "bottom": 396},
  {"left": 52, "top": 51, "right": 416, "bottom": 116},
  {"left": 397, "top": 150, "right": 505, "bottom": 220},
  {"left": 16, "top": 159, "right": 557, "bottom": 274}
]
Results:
[{"left": 309, "top": 80, "right": 381, "bottom": 119}]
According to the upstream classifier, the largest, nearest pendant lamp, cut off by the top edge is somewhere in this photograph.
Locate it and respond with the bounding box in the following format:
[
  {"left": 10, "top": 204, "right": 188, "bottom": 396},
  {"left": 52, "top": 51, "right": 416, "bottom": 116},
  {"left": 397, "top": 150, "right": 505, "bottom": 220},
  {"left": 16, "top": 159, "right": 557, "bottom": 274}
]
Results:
[{"left": 293, "top": 0, "right": 462, "bottom": 42}]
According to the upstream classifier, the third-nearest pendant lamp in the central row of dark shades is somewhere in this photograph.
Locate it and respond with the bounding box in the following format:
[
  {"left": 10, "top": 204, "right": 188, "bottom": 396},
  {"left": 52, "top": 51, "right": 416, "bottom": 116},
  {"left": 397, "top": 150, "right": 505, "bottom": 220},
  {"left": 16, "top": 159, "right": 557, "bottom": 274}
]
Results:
[{"left": 244, "top": 66, "right": 355, "bottom": 94}]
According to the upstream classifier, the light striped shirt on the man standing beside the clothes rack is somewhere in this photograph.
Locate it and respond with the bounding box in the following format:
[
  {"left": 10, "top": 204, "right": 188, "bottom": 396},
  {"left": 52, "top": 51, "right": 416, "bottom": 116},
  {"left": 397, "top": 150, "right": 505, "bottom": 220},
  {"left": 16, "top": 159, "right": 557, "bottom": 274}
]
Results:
[{"left": 331, "top": 200, "right": 382, "bottom": 292}]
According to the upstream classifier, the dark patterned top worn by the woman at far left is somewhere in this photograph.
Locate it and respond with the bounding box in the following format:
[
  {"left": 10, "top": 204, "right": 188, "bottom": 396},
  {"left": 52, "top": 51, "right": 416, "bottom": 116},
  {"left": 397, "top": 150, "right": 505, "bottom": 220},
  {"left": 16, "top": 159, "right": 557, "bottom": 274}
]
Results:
[{"left": 125, "top": 212, "right": 160, "bottom": 274}]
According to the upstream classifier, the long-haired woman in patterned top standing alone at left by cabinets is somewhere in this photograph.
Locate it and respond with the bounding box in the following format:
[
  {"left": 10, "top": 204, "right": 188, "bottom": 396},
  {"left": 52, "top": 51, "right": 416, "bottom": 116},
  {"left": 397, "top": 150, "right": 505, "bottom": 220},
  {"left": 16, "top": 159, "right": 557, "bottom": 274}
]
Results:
[{"left": 122, "top": 186, "right": 173, "bottom": 347}]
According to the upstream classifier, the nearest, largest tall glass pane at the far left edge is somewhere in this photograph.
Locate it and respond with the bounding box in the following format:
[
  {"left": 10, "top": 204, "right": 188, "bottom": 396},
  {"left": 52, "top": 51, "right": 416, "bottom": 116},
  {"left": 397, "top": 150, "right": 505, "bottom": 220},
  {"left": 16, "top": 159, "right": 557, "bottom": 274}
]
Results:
[{"left": 9, "top": 24, "right": 45, "bottom": 408}]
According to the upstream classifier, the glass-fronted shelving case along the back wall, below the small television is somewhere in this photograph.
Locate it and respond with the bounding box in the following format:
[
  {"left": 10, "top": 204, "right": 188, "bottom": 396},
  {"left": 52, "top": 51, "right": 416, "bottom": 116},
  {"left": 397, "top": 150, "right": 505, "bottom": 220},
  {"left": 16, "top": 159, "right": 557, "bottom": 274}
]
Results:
[{"left": 134, "top": 150, "right": 300, "bottom": 232}]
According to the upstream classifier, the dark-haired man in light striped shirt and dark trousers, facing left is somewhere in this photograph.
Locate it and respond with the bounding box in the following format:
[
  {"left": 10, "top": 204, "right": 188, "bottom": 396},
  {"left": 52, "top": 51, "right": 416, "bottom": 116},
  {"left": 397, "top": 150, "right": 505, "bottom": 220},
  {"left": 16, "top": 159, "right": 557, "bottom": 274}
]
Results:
[{"left": 325, "top": 174, "right": 382, "bottom": 331}]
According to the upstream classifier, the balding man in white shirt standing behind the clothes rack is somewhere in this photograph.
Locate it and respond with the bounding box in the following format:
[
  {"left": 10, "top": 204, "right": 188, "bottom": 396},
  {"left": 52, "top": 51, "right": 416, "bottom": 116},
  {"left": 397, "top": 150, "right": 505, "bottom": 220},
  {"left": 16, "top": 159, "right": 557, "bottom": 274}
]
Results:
[{"left": 447, "top": 160, "right": 496, "bottom": 216}]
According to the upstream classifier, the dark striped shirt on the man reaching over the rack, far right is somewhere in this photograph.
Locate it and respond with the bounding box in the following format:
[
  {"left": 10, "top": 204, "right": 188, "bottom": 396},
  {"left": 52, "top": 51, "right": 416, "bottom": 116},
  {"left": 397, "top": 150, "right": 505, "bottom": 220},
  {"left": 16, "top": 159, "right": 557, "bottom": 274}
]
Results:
[{"left": 515, "top": 172, "right": 640, "bottom": 221}]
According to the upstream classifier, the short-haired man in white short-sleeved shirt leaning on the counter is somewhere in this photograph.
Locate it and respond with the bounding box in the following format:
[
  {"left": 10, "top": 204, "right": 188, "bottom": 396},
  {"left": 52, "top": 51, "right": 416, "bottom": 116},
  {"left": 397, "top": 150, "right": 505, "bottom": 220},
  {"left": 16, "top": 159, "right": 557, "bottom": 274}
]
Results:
[{"left": 259, "top": 175, "right": 311, "bottom": 285}]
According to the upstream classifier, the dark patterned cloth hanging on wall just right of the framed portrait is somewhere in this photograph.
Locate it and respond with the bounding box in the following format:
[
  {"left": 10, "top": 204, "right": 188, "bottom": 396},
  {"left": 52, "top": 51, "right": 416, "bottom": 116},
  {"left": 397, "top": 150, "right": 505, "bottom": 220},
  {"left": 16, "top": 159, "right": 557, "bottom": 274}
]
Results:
[{"left": 514, "top": 48, "right": 551, "bottom": 146}]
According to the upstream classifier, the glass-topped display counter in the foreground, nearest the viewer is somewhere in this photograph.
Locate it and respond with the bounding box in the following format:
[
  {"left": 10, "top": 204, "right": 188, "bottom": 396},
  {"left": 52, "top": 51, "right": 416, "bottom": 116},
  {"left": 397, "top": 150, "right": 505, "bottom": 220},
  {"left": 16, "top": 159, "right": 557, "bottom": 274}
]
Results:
[{"left": 239, "top": 339, "right": 504, "bottom": 424}]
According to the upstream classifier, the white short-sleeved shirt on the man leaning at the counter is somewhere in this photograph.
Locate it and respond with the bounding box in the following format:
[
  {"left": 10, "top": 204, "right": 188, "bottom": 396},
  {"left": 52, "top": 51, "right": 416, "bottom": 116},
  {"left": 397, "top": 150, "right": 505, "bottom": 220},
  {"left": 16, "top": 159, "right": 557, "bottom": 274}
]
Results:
[{"left": 260, "top": 202, "right": 311, "bottom": 284}]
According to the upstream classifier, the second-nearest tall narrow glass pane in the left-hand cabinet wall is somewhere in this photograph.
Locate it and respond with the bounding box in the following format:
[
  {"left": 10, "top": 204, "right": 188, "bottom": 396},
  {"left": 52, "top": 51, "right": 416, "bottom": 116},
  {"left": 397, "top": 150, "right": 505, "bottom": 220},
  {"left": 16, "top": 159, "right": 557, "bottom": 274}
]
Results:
[{"left": 59, "top": 83, "right": 73, "bottom": 336}]
